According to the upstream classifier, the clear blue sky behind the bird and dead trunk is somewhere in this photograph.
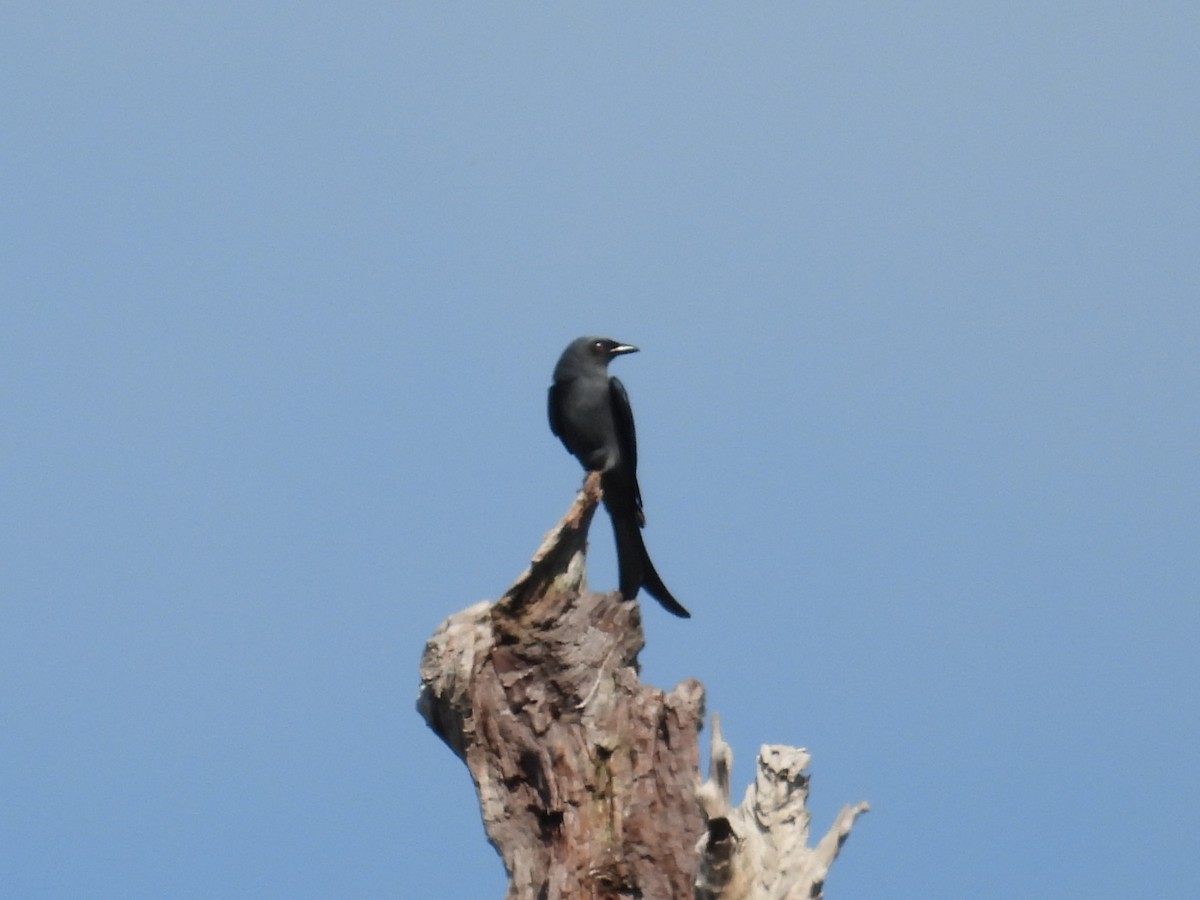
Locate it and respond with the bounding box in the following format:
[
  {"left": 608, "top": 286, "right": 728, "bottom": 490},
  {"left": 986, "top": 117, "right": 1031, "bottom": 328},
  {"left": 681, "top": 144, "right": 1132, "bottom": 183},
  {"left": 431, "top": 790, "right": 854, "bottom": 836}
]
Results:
[{"left": 0, "top": 7, "right": 1200, "bottom": 900}]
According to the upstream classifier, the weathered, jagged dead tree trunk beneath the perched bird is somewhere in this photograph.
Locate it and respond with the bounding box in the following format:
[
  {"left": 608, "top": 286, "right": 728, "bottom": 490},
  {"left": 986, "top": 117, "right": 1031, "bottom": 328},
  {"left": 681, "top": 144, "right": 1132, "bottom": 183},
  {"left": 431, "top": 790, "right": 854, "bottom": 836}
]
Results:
[{"left": 418, "top": 475, "right": 865, "bottom": 900}]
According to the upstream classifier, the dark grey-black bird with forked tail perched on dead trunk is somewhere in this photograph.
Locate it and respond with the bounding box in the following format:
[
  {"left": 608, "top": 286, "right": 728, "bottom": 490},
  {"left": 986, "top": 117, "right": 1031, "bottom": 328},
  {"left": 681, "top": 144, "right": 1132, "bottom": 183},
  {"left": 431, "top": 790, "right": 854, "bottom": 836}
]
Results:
[{"left": 550, "top": 337, "right": 691, "bottom": 619}]
